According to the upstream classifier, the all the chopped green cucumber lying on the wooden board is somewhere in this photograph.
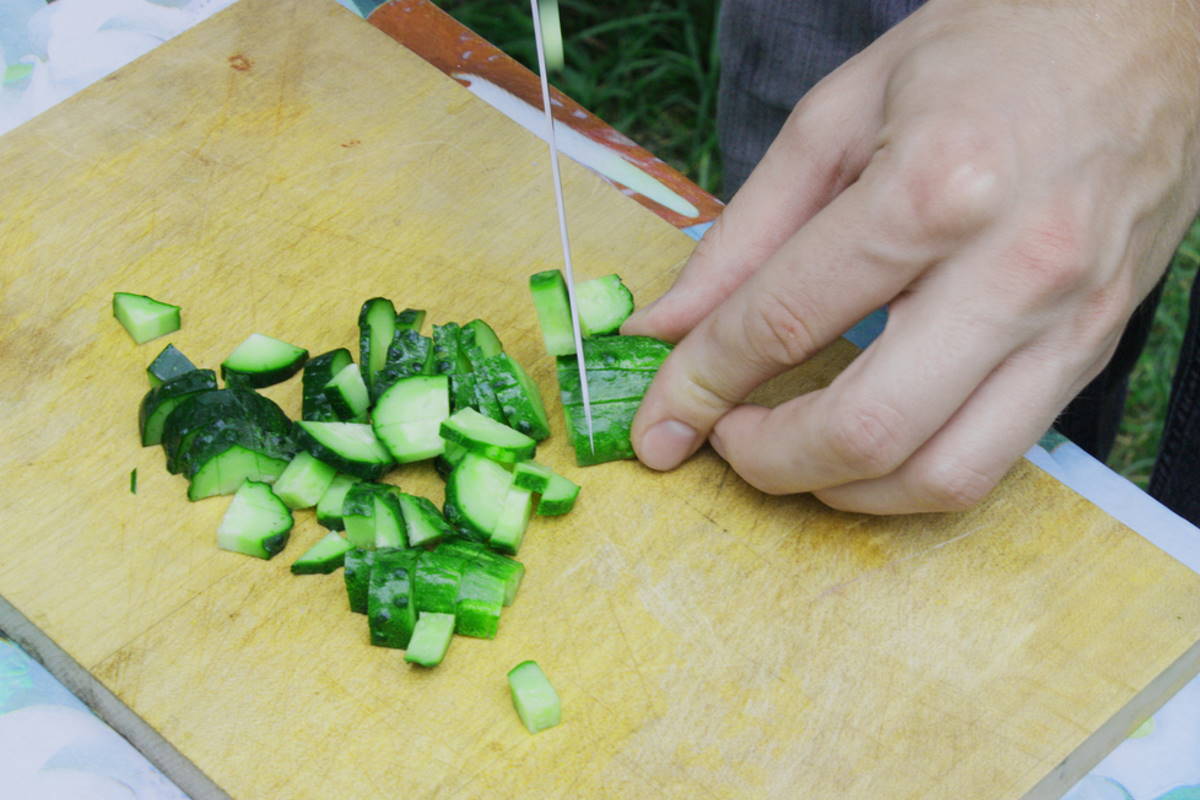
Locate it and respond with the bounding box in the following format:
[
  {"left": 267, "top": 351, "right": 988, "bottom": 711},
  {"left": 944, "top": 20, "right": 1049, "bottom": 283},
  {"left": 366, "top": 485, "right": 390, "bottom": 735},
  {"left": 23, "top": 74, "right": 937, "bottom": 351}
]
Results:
[{"left": 114, "top": 270, "right": 670, "bottom": 732}]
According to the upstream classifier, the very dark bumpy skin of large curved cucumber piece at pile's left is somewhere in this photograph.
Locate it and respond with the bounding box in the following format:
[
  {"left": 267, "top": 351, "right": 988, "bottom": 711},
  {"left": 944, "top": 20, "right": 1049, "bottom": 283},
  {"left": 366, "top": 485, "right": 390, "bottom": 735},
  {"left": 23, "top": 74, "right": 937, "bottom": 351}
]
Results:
[{"left": 162, "top": 387, "right": 294, "bottom": 473}]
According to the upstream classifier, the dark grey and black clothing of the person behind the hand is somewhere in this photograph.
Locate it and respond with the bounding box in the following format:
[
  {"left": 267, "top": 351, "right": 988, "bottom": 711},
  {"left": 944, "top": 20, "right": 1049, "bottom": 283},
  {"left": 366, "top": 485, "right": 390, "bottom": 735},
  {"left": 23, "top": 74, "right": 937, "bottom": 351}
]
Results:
[{"left": 716, "top": 0, "right": 1200, "bottom": 524}]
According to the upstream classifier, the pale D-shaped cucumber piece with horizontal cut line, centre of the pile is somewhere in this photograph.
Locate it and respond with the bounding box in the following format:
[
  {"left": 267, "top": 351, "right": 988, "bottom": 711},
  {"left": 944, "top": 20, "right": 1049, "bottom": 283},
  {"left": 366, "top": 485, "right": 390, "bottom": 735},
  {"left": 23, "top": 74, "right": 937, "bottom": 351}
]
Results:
[{"left": 371, "top": 375, "right": 450, "bottom": 464}]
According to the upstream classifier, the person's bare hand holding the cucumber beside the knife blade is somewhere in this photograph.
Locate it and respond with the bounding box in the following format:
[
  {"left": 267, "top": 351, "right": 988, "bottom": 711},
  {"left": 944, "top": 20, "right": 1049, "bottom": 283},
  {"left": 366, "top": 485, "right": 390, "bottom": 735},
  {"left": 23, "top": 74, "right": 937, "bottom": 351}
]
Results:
[{"left": 623, "top": 0, "right": 1200, "bottom": 513}]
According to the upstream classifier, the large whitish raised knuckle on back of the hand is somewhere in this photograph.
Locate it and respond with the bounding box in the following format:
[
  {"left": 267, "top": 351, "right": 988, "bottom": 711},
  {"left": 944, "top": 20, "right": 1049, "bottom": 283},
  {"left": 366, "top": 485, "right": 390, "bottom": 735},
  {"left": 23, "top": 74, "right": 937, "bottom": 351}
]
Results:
[{"left": 881, "top": 116, "right": 1012, "bottom": 241}]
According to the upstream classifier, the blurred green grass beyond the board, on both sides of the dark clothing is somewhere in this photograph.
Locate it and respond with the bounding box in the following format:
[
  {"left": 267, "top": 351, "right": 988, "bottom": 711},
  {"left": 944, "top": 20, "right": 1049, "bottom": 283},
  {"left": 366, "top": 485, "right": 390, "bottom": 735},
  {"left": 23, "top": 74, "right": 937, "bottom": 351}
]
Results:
[{"left": 439, "top": 0, "right": 1200, "bottom": 488}]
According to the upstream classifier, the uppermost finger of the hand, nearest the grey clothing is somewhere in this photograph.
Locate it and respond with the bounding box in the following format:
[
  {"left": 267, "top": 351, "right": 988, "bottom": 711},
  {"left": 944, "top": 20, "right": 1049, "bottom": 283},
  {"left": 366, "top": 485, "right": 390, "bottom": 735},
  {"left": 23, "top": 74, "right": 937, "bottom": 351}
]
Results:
[{"left": 622, "top": 61, "right": 883, "bottom": 342}]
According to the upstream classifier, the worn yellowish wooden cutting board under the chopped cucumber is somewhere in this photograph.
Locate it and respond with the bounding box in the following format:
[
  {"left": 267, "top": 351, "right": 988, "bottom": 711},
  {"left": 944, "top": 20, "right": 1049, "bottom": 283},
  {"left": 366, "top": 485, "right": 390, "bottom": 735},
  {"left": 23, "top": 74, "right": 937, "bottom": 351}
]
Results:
[{"left": 0, "top": 0, "right": 1200, "bottom": 800}]
